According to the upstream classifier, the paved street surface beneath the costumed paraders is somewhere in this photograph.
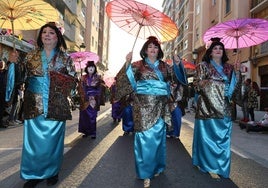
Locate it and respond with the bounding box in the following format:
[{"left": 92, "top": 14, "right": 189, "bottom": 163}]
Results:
[{"left": 0, "top": 103, "right": 268, "bottom": 188}]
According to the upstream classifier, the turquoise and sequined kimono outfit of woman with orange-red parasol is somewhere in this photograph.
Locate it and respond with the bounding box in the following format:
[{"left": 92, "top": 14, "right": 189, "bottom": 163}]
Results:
[{"left": 126, "top": 58, "right": 187, "bottom": 179}]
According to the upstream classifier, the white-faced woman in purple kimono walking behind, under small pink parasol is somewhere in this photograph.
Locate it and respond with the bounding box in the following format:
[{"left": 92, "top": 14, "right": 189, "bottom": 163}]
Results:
[{"left": 78, "top": 61, "right": 102, "bottom": 139}]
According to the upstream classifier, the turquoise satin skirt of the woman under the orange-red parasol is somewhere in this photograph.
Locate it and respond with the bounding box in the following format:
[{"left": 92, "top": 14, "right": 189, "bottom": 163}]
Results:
[{"left": 134, "top": 118, "right": 166, "bottom": 179}]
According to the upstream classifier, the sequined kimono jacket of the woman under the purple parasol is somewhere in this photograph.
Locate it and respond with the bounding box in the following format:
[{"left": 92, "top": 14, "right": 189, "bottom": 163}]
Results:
[{"left": 194, "top": 62, "right": 241, "bottom": 119}]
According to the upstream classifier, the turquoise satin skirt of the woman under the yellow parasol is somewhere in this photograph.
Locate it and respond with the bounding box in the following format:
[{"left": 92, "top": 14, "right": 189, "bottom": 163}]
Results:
[{"left": 20, "top": 115, "right": 66, "bottom": 180}]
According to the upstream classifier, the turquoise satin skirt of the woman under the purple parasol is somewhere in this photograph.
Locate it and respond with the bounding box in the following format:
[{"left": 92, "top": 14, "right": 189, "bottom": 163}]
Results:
[{"left": 192, "top": 118, "right": 232, "bottom": 178}]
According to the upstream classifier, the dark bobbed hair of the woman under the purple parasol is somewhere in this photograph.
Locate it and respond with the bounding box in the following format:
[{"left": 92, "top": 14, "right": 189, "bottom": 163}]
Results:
[{"left": 202, "top": 37, "right": 229, "bottom": 63}]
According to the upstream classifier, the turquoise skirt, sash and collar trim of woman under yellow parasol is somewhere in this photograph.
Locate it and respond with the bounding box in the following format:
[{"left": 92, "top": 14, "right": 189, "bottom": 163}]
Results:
[{"left": 20, "top": 51, "right": 66, "bottom": 180}]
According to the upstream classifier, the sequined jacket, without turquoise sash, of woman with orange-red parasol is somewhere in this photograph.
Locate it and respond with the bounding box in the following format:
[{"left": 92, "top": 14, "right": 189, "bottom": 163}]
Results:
[{"left": 115, "top": 60, "right": 186, "bottom": 132}]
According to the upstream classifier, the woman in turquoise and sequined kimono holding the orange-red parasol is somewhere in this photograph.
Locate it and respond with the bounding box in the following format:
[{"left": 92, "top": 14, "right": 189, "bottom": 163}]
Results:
[{"left": 116, "top": 36, "right": 187, "bottom": 187}]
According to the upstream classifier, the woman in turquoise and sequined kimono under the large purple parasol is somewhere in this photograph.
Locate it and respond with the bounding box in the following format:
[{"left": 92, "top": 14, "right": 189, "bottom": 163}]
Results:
[{"left": 192, "top": 38, "right": 241, "bottom": 178}]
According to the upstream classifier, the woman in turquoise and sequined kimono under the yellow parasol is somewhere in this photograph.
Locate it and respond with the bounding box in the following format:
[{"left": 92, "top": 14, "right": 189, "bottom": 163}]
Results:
[{"left": 8, "top": 23, "right": 76, "bottom": 188}]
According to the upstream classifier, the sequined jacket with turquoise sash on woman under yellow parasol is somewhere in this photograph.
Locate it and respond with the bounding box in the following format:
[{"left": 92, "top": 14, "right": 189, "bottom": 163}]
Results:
[{"left": 24, "top": 50, "right": 76, "bottom": 120}]
